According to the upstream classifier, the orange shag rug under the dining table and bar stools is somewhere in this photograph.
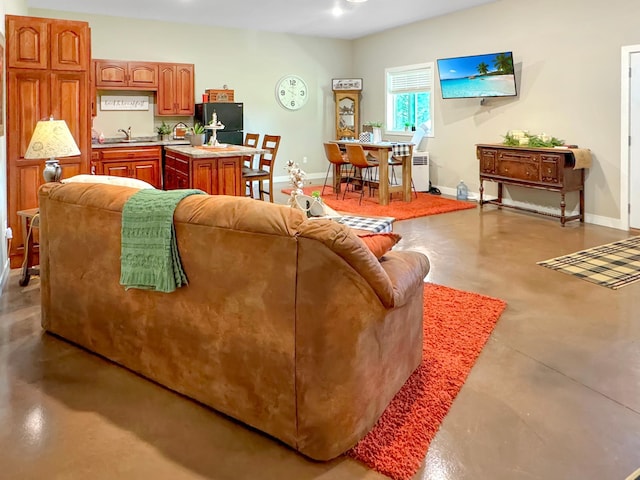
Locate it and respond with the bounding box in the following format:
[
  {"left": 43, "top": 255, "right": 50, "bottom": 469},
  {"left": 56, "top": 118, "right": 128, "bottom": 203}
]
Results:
[{"left": 282, "top": 185, "right": 477, "bottom": 220}]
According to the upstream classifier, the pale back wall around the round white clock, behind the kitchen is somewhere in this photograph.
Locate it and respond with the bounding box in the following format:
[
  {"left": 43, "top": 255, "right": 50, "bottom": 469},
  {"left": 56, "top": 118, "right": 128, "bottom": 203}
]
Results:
[{"left": 30, "top": 9, "right": 353, "bottom": 182}]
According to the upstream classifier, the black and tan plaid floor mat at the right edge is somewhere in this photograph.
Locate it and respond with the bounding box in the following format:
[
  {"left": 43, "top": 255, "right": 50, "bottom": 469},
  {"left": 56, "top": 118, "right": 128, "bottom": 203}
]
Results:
[{"left": 538, "top": 237, "right": 640, "bottom": 290}]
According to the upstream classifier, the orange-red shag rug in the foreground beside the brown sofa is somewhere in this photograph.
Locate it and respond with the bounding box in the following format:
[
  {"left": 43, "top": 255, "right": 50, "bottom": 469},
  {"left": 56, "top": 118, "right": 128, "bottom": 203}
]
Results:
[{"left": 347, "top": 283, "right": 506, "bottom": 480}]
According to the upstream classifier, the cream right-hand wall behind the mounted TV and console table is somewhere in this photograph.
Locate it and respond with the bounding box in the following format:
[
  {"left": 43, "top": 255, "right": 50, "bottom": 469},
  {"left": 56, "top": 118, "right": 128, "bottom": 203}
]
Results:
[{"left": 354, "top": 0, "right": 640, "bottom": 224}]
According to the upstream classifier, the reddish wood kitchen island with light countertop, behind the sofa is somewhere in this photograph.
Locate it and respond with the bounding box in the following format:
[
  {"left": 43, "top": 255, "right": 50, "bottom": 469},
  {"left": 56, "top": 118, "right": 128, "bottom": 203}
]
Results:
[{"left": 164, "top": 145, "right": 264, "bottom": 196}]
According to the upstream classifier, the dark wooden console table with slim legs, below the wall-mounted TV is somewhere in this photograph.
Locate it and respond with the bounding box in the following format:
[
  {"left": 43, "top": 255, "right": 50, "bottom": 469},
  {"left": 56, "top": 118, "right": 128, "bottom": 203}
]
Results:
[{"left": 476, "top": 144, "right": 585, "bottom": 227}]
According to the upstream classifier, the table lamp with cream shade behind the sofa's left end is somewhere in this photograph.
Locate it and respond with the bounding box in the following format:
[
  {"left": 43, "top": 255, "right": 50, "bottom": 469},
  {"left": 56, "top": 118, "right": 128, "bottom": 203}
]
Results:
[{"left": 24, "top": 117, "right": 80, "bottom": 182}]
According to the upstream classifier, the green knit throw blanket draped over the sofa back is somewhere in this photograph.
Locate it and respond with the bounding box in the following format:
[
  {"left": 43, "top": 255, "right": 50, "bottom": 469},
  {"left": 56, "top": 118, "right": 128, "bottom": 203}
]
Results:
[{"left": 120, "top": 189, "right": 204, "bottom": 293}]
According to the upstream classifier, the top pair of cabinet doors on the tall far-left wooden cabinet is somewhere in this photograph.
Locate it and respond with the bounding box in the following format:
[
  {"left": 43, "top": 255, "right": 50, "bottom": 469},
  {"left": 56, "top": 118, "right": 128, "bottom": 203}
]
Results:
[{"left": 7, "top": 15, "right": 91, "bottom": 71}]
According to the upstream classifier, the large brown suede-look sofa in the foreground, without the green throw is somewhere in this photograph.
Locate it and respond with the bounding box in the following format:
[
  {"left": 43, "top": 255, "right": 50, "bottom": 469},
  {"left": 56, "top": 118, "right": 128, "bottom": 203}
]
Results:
[{"left": 40, "top": 183, "right": 429, "bottom": 460}]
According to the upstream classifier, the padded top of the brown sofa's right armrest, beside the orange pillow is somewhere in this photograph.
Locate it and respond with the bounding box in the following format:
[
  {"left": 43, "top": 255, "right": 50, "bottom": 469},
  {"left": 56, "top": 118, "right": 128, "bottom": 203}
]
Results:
[{"left": 380, "top": 251, "right": 430, "bottom": 307}]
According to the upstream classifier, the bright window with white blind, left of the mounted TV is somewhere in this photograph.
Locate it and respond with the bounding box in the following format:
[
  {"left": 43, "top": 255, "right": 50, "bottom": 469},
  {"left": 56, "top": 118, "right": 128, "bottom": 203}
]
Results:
[{"left": 386, "top": 62, "right": 433, "bottom": 137}]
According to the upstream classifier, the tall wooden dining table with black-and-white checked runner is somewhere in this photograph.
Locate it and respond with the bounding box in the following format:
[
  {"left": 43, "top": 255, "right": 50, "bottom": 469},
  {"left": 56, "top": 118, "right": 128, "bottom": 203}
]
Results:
[{"left": 333, "top": 140, "right": 413, "bottom": 205}]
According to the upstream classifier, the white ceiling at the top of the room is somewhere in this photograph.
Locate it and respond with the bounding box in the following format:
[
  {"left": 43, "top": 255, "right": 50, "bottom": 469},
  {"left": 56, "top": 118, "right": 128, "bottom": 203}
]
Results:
[{"left": 27, "top": 0, "right": 495, "bottom": 39}]
